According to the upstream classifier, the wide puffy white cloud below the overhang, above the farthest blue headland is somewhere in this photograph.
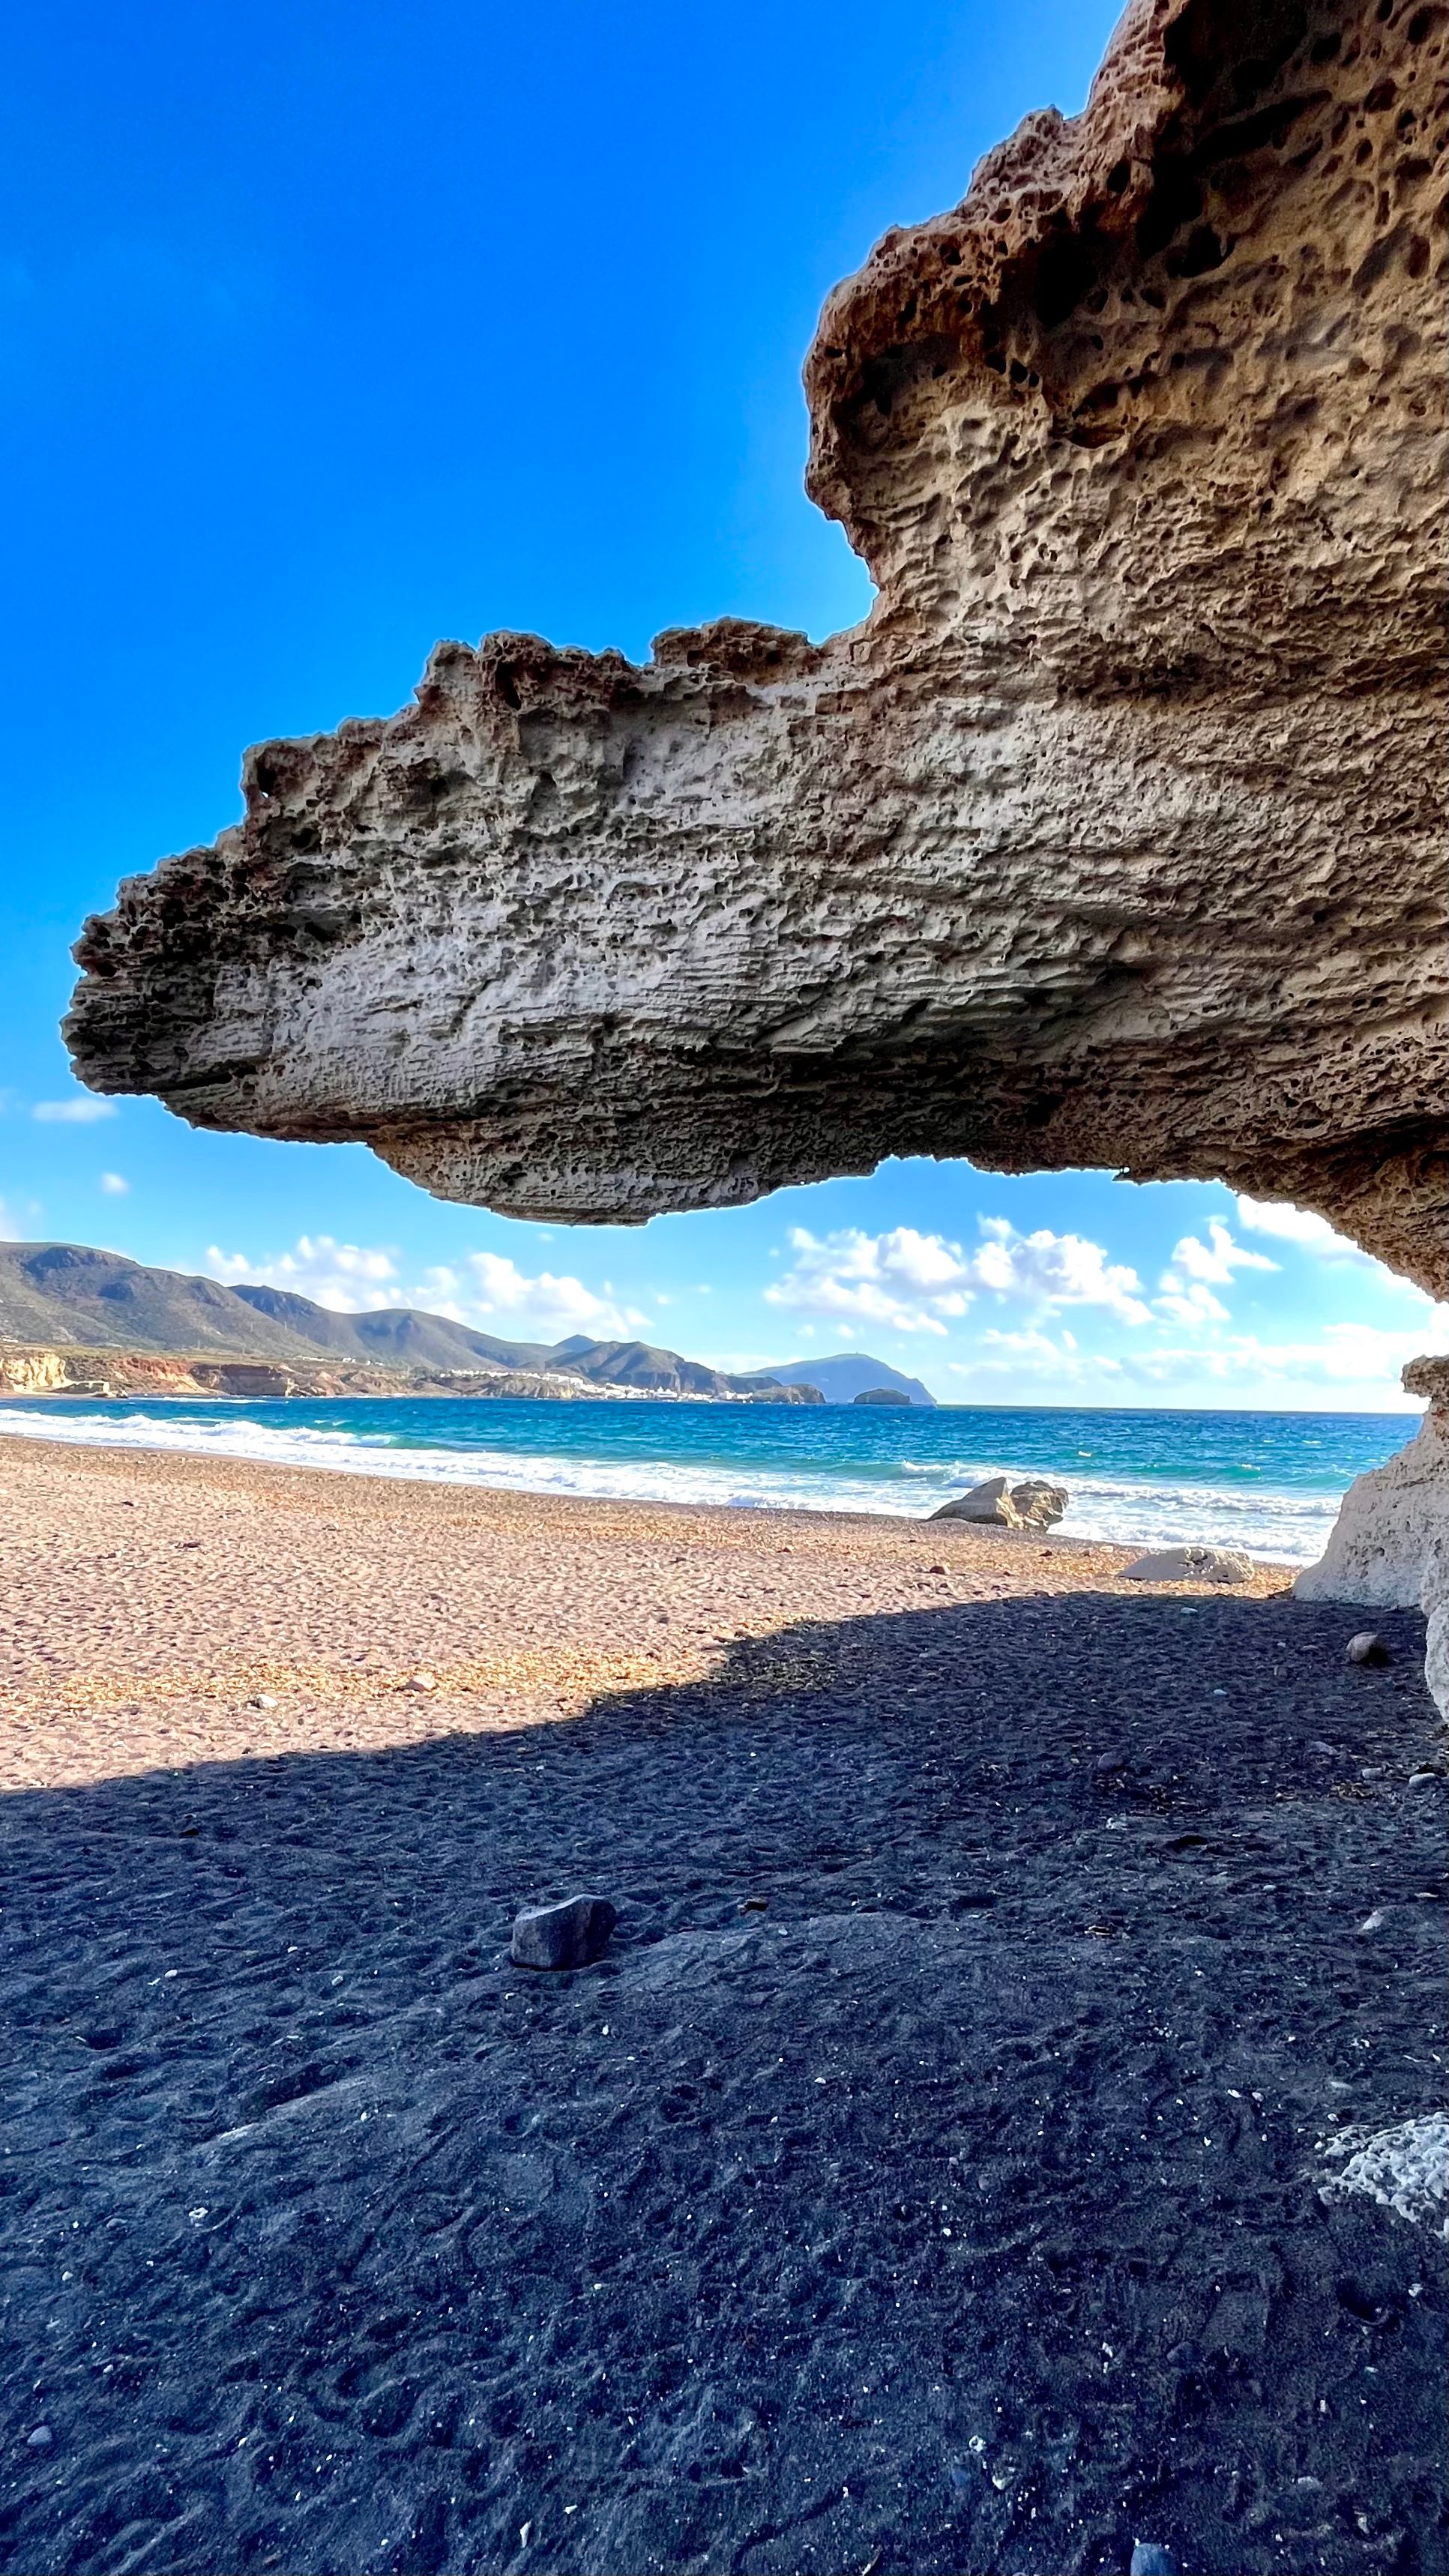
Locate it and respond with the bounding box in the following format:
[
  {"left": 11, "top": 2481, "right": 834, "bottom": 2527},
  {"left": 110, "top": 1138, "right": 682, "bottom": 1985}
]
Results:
[{"left": 763, "top": 1216, "right": 1150, "bottom": 1334}]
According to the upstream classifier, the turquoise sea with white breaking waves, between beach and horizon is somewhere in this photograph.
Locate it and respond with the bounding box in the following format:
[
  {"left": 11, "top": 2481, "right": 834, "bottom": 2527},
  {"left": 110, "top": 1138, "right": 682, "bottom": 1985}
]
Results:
[{"left": 0, "top": 1396, "right": 1415, "bottom": 1563}]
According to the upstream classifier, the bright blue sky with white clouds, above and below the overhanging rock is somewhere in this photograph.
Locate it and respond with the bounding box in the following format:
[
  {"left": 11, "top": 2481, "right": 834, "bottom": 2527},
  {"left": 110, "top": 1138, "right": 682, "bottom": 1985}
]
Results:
[{"left": 0, "top": 0, "right": 1449, "bottom": 1409}]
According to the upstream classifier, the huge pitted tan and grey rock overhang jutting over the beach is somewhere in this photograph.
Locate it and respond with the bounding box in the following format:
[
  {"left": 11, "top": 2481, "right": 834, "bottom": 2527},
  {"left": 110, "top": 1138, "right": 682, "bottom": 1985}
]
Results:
[{"left": 67, "top": 0, "right": 1447, "bottom": 1285}]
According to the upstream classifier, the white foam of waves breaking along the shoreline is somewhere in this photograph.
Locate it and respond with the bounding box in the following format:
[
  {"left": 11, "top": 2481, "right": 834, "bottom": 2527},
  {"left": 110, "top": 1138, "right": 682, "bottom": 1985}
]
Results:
[{"left": 0, "top": 1407, "right": 1341, "bottom": 1563}]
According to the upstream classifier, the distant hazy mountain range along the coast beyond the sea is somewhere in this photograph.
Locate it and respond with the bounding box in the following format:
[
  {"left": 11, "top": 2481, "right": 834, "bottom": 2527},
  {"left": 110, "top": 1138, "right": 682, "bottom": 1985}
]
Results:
[{"left": 0, "top": 1244, "right": 933, "bottom": 1404}]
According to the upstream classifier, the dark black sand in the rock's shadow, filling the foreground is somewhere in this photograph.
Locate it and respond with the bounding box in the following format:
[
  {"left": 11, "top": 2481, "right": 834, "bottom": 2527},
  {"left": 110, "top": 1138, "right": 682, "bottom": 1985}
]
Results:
[{"left": 0, "top": 1595, "right": 1447, "bottom": 2576}]
